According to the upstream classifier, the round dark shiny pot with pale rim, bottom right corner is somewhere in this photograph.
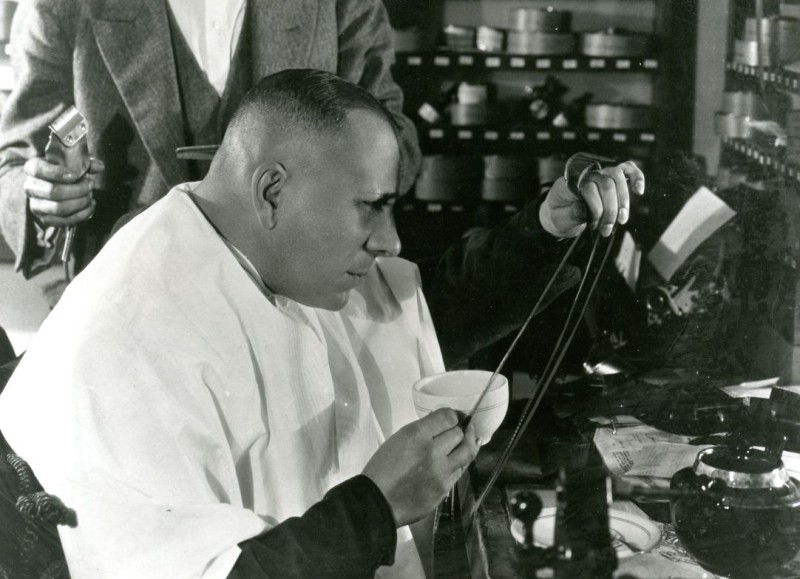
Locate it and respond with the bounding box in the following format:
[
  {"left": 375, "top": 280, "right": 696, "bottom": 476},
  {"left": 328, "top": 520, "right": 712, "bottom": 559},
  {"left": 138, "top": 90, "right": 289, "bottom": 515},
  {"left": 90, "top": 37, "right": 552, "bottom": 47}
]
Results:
[{"left": 671, "top": 447, "right": 800, "bottom": 579}]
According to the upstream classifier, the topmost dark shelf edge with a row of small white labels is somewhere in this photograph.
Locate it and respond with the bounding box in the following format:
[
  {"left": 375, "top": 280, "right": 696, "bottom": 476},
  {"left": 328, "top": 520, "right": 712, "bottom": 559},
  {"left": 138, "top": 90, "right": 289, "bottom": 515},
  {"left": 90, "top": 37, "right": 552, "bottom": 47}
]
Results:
[{"left": 394, "top": 50, "right": 660, "bottom": 72}]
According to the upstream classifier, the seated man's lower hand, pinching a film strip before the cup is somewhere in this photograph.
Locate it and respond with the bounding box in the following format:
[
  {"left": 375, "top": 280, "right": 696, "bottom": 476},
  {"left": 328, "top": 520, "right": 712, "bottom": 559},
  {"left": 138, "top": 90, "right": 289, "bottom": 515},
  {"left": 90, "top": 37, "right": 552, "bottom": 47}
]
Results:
[{"left": 364, "top": 408, "right": 479, "bottom": 527}]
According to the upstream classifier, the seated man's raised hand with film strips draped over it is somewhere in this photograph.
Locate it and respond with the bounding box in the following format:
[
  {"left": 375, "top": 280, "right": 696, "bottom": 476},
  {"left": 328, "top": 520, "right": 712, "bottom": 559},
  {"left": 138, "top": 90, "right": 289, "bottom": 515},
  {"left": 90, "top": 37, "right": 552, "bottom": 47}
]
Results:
[{"left": 539, "top": 161, "right": 644, "bottom": 237}]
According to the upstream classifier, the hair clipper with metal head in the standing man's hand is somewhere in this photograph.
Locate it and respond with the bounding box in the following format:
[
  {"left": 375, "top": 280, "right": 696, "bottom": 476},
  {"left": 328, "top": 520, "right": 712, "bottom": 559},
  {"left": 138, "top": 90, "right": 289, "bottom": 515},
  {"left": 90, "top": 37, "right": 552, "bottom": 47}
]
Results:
[{"left": 44, "top": 105, "right": 91, "bottom": 263}]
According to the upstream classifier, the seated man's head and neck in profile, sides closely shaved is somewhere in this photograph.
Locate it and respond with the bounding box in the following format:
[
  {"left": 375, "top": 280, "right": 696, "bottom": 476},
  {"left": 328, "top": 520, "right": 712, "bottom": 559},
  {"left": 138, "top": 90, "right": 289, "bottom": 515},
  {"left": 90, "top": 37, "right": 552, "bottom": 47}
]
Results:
[{"left": 192, "top": 70, "right": 400, "bottom": 310}]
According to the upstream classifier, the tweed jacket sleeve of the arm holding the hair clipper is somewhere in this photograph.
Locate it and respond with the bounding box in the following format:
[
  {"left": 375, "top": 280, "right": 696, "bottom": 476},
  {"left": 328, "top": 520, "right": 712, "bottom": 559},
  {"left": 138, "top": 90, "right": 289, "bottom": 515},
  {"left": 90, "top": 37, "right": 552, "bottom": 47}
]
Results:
[{"left": 0, "top": 0, "right": 74, "bottom": 277}]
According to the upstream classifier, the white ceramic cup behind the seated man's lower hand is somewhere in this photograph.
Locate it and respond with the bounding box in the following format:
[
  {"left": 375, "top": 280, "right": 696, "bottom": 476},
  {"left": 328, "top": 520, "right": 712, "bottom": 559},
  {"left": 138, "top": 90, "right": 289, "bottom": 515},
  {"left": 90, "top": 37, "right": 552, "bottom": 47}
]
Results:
[{"left": 412, "top": 370, "right": 508, "bottom": 444}]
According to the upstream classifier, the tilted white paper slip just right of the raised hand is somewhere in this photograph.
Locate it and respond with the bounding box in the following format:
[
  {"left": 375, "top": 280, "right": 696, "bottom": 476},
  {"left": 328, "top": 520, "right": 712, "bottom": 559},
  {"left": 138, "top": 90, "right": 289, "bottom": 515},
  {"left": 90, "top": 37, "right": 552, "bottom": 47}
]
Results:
[{"left": 647, "top": 187, "right": 736, "bottom": 281}]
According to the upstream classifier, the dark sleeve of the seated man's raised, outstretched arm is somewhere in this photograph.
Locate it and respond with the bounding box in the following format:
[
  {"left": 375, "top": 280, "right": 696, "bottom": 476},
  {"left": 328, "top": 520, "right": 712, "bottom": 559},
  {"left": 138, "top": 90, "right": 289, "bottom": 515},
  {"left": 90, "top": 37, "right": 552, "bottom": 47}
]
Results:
[{"left": 418, "top": 196, "right": 580, "bottom": 368}]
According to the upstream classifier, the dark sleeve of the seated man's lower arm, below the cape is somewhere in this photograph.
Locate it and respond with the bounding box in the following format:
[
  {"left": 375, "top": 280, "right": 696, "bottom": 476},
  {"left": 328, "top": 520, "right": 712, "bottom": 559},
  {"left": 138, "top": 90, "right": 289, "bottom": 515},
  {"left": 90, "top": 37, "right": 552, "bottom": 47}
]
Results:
[{"left": 228, "top": 475, "right": 397, "bottom": 579}]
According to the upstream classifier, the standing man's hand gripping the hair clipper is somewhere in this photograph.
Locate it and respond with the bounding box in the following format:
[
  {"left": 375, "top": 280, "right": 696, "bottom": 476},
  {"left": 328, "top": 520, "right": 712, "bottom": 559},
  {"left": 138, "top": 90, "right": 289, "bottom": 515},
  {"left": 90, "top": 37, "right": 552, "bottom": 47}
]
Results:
[{"left": 23, "top": 157, "right": 105, "bottom": 227}]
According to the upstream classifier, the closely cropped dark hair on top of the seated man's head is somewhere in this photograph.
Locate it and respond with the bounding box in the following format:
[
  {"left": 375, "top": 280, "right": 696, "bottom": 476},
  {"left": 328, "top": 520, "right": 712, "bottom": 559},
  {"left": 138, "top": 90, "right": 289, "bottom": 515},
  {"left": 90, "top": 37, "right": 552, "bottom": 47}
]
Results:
[{"left": 230, "top": 69, "right": 398, "bottom": 135}]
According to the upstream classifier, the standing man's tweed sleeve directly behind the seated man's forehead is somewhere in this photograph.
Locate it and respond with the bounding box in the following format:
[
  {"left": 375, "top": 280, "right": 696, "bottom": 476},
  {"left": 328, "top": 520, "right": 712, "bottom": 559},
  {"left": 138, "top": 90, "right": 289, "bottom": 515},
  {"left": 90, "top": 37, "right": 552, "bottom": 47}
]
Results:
[{"left": 336, "top": 0, "right": 421, "bottom": 193}]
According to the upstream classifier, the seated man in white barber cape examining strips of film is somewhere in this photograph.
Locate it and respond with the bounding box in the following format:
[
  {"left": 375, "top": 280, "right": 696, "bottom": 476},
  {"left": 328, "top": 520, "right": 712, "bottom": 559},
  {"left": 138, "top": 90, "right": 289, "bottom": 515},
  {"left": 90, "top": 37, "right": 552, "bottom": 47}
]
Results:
[{"left": 0, "top": 70, "right": 643, "bottom": 579}]
